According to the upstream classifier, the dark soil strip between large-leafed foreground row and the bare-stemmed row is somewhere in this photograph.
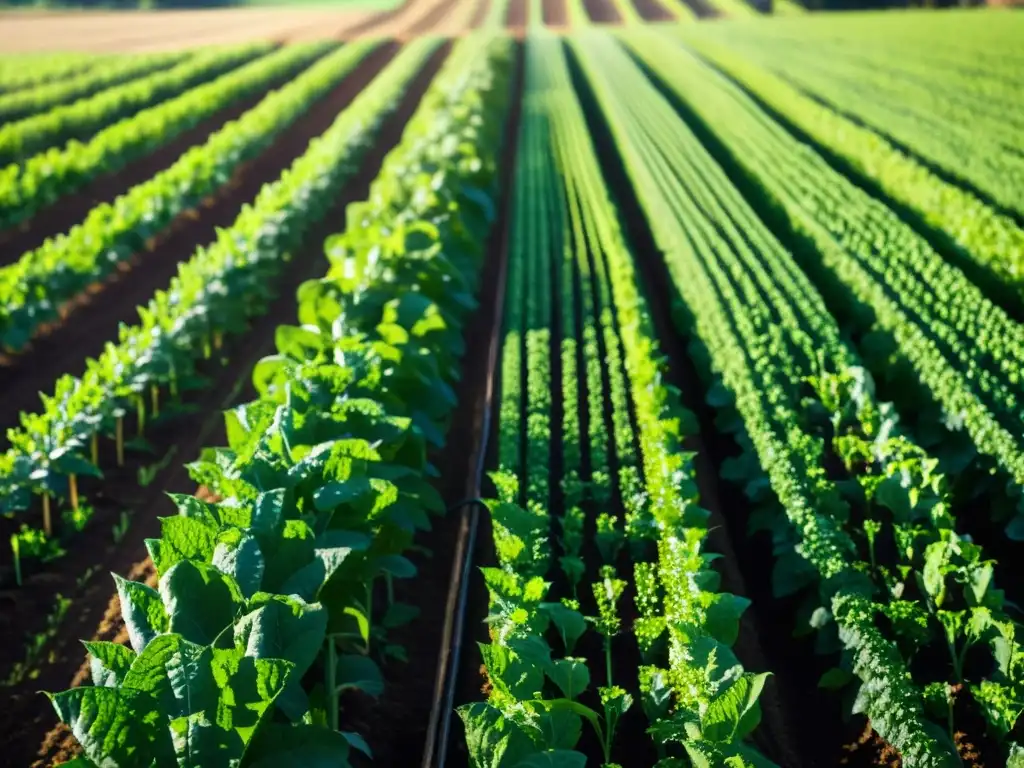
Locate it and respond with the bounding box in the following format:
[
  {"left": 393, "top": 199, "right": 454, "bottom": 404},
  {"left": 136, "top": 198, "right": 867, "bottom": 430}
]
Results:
[{"left": 0, "top": 40, "right": 445, "bottom": 766}]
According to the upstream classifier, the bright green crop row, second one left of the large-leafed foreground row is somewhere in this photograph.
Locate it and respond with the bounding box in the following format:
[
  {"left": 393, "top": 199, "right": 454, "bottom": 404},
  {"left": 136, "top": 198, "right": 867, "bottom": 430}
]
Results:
[{"left": 0, "top": 42, "right": 378, "bottom": 350}]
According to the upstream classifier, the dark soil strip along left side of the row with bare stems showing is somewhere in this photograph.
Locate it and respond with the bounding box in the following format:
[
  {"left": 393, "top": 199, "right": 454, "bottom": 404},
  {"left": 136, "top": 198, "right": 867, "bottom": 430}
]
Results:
[{"left": 0, "top": 44, "right": 394, "bottom": 454}]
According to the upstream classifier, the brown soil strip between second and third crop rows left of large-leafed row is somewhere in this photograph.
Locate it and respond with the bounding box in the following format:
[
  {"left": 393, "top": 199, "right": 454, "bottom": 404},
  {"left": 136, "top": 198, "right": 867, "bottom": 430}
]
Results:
[{"left": 0, "top": 49, "right": 313, "bottom": 266}]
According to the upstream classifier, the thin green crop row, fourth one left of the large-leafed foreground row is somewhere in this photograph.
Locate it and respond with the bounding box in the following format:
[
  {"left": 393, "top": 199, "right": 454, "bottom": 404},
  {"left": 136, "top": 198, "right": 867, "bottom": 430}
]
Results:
[{"left": 0, "top": 43, "right": 269, "bottom": 166}]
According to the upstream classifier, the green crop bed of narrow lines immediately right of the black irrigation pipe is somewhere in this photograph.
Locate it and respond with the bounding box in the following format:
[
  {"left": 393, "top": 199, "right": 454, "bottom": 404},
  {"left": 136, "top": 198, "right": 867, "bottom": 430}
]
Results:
[{"left": 460, "top": 33, "right": 771, "bottom": 768}]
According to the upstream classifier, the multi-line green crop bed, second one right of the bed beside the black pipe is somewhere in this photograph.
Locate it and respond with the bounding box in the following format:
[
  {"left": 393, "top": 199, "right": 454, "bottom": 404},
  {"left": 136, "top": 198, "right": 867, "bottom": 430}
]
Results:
[{"left": 630, "top": 31, "right": 1024, "bottom": 539}]
